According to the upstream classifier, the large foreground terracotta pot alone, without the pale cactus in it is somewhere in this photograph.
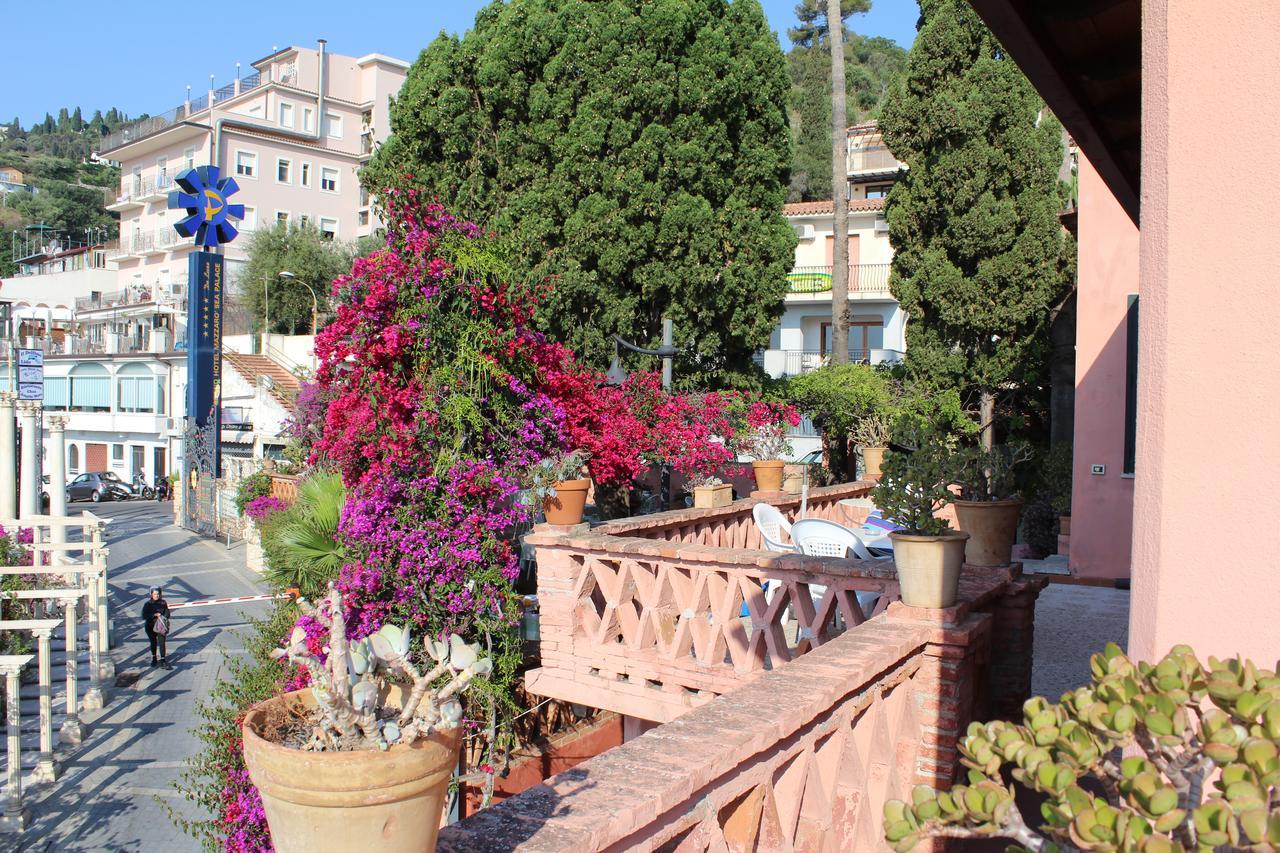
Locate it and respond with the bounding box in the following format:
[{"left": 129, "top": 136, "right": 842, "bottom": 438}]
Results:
[{"left": 242, "top": 688, "right": 462, "bottom": 853}]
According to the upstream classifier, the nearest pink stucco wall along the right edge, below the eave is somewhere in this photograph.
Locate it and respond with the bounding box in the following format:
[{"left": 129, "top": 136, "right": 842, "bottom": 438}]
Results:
[{"left": 1131, "top": 0, "right": 1280, "bottom": 666}]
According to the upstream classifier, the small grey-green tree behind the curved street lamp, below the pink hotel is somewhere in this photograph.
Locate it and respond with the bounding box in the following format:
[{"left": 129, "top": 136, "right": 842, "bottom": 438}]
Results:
[{"left": 238, "top": 223, "right": 356, "bottom": 334}]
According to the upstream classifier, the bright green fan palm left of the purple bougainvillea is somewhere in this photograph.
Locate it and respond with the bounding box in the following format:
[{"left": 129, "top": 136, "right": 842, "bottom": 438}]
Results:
[{"left": 262, "top": 473, "right": 347, "bottom": 598}]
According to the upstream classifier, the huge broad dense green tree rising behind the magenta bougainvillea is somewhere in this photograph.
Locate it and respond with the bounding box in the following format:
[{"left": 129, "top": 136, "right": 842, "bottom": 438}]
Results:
[{"left": 361, "top": 0, "right": 795, "bottom": 384}]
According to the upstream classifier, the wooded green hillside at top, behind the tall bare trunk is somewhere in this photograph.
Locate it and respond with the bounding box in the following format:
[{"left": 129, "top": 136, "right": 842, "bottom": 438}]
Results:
[{"left": 787, "top": 0, "right": 906, "bottom": 201}]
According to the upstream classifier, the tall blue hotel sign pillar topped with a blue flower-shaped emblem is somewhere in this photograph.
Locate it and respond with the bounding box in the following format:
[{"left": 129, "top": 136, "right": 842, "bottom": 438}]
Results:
[{"left": 169, "top": 165, "right": 244, "bottom": 478}]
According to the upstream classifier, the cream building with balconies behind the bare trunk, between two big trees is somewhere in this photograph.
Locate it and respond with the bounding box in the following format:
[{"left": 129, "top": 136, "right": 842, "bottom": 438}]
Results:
[{"left": 762, "top": 122, "right": 906, "bottom": 377}]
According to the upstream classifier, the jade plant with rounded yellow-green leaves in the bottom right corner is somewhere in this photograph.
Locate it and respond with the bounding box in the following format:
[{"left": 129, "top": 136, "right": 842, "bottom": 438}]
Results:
[{"left": 884, "top": 643, "right": 1280, "bottom": 853}]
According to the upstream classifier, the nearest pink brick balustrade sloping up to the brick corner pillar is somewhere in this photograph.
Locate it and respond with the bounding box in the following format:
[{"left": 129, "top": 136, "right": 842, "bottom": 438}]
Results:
[{"left": 438, "top": 573, "right": 1015, "bottom": 853}]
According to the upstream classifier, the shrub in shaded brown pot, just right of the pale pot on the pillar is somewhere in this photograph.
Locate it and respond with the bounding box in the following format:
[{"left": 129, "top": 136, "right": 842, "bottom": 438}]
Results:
[{"left": 954, "top": 443, "right": 1032, "bottom": 566}]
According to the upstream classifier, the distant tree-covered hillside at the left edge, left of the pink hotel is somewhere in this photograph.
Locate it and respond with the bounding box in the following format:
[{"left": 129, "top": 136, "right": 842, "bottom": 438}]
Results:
[{"left": 0, "top": 106, "right": 131, "bottom": 275}]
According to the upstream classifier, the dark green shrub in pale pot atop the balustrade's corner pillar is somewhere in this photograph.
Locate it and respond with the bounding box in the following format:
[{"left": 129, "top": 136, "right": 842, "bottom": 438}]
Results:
[{"left": 872, "top": 430, "right": 969, "bottom": 607}]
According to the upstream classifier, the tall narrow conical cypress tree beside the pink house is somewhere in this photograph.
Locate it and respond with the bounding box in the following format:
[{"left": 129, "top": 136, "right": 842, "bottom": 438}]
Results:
[{"left": 881, "top": 0, "right": 1074, "bottom": 443}]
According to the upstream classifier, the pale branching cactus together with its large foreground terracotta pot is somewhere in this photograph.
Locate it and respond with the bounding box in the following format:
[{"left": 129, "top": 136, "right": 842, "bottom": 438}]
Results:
[{"left": 242, "top": 585, "right": 492, "bottom": 853}]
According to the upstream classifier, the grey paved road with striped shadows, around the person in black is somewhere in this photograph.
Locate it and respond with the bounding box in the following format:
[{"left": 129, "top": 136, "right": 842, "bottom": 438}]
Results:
[{"left": 0, "top": 502, "right": 268, "bottom": 853}]
